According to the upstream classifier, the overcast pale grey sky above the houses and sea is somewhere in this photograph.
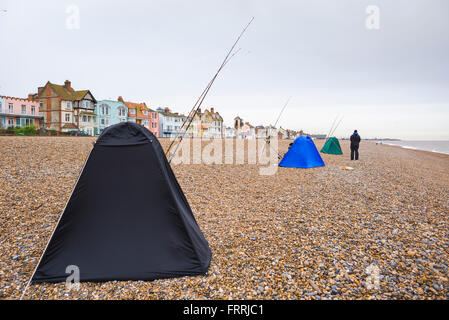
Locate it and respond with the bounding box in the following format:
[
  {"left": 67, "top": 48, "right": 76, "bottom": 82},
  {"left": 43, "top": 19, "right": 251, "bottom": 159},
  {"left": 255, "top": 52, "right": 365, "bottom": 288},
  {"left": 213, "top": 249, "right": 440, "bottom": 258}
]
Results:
[{"left": 0, "top": 0, "right": 449, "bottom": 140}]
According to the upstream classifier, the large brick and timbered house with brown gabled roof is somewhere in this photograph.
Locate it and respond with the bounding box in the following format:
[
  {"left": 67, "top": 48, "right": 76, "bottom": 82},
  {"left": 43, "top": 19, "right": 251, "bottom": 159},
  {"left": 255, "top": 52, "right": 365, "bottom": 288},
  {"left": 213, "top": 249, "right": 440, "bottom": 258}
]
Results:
[{"left": 34, "top": 80, "right": 97, "bottom": 135}]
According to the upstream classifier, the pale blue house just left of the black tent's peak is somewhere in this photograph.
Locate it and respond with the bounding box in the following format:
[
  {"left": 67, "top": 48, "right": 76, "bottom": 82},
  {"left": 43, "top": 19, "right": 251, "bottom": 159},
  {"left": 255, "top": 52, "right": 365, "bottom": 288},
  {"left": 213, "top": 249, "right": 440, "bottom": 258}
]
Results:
[{"left": 95, "top": 100, "right": 128, "bottom": 135}]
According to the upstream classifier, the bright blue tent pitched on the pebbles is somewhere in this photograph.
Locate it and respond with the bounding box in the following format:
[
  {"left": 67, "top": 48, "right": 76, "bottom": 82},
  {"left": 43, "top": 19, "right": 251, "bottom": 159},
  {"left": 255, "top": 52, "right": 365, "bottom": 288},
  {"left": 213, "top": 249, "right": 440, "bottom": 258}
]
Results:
[{"left": 279, "top": 136, "right": 324, "bottom": 168}]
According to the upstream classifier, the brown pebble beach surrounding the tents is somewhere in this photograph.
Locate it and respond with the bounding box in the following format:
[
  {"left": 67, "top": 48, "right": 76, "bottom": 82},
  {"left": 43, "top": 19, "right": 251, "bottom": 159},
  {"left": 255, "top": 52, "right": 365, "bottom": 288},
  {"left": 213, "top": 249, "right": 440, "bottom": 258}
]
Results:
[{"left": 0, "top": 137, "right": 449, "bottom": 300}]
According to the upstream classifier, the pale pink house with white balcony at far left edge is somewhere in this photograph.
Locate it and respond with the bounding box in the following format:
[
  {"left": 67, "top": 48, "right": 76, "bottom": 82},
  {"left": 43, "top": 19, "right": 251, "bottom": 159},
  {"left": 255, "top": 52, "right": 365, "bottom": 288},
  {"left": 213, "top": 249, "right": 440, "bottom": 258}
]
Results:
[{"left": 0, "top": 95, "right": 43, "bottom": 129}]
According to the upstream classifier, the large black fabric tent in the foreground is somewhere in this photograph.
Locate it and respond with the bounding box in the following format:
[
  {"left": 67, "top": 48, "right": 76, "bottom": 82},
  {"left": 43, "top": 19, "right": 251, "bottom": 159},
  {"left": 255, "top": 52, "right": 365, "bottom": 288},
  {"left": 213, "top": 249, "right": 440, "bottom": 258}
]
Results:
[{"left": 32, "top": 122, "right": 211, "bottom": 282}]
